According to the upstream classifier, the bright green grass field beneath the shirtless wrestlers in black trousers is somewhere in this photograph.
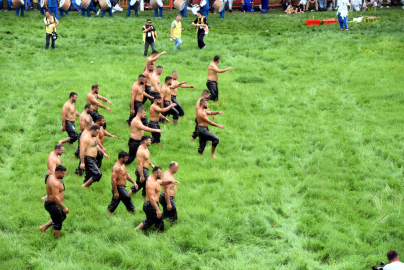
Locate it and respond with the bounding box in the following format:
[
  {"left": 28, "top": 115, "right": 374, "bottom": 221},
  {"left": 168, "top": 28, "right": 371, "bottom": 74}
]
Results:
[{"left": 0, "top": 7, "right": 404, "bottom": 270}]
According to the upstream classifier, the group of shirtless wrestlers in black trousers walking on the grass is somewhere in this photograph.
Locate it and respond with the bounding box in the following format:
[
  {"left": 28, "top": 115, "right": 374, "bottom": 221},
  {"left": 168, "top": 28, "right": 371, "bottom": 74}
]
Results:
[{"left": 39, "top": 51, "right": 232, "bottom": 238}]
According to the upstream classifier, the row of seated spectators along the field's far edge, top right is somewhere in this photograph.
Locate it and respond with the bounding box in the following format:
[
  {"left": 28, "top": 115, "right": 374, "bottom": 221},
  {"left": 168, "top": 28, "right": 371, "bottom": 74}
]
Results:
[{"left": 282, "top": 0, "right": 404, "bottom": 14}]
